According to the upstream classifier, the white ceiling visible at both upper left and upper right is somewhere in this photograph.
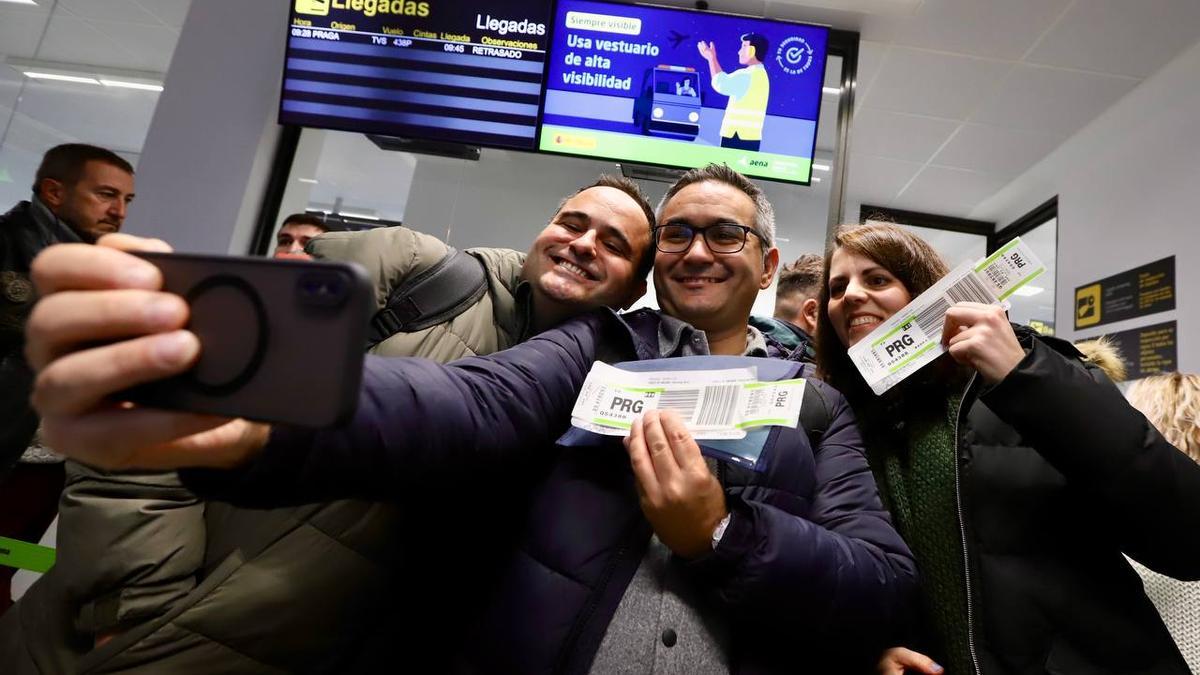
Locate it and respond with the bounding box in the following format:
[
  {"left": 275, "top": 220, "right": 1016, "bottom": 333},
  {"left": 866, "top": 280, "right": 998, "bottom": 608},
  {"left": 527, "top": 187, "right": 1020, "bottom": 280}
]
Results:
[{"left": 0, "top": 0, "right": 1200, "bottom": 225}]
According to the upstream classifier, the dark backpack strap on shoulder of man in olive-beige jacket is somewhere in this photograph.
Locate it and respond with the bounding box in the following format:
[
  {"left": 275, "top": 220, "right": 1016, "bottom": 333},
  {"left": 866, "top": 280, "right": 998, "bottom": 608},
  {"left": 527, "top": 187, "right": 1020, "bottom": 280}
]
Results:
[{"left": 367, "top": 247, "right": 487, "bottom": 348}]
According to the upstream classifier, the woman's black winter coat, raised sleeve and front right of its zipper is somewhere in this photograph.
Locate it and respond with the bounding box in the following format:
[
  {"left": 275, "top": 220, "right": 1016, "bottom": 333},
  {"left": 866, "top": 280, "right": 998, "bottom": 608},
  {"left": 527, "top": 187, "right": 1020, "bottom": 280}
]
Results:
[{"left": 907, "top": 329, "right": 1200, "bottom": 675}]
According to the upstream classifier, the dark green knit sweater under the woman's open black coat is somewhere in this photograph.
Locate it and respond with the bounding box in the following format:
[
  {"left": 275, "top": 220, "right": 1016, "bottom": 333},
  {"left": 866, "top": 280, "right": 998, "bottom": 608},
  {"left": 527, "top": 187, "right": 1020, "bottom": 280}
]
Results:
[{"left": 876, "top": 396, "right": 971, "bottom": 675}]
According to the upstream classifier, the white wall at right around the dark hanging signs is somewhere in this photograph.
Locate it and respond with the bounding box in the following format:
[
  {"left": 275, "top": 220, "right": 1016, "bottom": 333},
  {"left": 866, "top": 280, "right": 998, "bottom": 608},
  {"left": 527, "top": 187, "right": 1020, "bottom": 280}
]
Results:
[{"left": 971, "top": 36, "right": 1200, "bottom": 371}]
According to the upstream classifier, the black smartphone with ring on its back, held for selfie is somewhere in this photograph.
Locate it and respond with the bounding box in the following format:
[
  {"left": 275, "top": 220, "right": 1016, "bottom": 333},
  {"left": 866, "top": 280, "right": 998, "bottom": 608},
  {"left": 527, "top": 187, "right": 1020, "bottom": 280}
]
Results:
[{"left": 127, "top": 252, "right": 374, "bottom": 428}]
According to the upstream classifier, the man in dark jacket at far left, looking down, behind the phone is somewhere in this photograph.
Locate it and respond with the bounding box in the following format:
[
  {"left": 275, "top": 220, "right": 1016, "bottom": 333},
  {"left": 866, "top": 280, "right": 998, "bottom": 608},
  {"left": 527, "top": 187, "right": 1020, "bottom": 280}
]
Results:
[{"left": 0, "top": 143, "right": 133, "bottom": 613}]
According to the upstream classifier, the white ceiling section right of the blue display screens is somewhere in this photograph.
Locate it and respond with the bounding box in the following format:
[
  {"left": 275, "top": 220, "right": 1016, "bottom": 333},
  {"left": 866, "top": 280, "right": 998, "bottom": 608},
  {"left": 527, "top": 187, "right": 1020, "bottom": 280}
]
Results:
[{"left": 816, "top": 0, "right": 1200, "bottom": 225}]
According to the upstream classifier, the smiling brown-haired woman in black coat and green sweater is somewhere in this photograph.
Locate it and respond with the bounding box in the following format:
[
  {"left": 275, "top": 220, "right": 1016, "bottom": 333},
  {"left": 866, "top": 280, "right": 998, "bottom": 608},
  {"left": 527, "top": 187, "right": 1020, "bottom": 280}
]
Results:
[{"left": 817, "top": 223, "right": 1200, "bottom": 675}]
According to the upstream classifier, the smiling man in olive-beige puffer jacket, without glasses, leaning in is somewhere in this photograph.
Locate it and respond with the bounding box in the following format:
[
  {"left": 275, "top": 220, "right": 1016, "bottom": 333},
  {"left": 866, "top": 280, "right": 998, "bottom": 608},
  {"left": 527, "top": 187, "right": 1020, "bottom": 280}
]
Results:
[{"left": 2, "top": 175, "right": 654, "bottom": 670}]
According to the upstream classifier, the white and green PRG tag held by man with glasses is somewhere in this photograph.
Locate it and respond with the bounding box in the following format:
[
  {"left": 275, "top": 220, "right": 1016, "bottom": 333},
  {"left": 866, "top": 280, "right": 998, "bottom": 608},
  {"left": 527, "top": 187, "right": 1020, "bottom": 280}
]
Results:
[{"left": 571, "top": 362, "right": 804, "bottom": 440}]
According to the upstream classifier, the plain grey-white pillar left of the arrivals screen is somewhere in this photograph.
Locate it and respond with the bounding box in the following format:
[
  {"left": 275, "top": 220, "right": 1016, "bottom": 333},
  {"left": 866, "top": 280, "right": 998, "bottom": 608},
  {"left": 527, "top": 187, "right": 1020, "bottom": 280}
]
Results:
[{"left": 125, "top": 0, "right": 288, "bottom": 253}]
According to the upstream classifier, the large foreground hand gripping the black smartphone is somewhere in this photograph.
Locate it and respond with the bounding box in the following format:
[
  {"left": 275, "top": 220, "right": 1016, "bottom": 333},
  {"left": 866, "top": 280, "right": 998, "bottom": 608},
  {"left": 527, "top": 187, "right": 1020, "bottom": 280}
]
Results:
[{"left": 26, "top": 234, "right": 361, "bottom": 470}]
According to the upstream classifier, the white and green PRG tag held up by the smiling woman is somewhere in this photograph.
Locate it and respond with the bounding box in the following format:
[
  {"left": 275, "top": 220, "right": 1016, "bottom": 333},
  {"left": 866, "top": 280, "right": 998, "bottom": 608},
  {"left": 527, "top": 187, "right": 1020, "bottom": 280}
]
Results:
[{"left": 848, "top": 238, "right": 1045, "bottom": 395}]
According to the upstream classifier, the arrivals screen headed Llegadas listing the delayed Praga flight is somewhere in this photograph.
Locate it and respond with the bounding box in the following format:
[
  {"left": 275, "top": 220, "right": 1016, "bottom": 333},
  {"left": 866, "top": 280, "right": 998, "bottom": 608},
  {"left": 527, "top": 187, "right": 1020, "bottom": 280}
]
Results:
[{"left": 280, "top": 0, "right": 550, "bottom": 150}]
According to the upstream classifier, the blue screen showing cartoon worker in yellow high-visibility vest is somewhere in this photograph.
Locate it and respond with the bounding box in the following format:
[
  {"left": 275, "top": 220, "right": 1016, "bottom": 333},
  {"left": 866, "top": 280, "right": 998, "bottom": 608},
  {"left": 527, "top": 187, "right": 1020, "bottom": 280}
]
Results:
[{"left": 539, "top": 0, "right": 829, "bottom": 185}]
